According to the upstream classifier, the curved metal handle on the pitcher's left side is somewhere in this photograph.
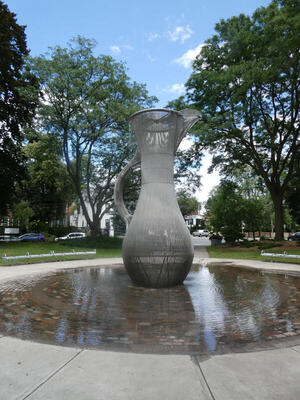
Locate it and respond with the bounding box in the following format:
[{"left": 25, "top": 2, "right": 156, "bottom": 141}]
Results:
[{"left": 114, "top": 150, "right": 141, "bottom": 229}]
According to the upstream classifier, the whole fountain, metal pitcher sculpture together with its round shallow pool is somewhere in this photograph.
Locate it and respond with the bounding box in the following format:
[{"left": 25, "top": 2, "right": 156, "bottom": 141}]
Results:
[{"left": 0, "top": 109, "right": 300, "bottom": 354}]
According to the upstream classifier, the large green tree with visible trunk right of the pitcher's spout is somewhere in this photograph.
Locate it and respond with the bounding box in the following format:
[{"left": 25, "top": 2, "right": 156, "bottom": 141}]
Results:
[{"left": 181, "top": 0, "right": 300, "bottom": 240}]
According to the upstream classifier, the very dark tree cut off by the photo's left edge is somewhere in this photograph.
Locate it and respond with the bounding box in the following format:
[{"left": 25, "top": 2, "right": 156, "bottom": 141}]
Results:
[{"left": 0, "top": 1, "right": 37, "bottom": 215}]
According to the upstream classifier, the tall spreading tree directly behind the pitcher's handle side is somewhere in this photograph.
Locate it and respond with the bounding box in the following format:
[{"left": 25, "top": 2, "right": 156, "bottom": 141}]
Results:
[{"left": 31, "top": 37, "right": 156, "bottom": 235}]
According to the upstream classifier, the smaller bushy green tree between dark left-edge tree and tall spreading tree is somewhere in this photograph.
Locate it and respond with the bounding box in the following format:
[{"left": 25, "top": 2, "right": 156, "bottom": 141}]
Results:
[{"left": 20, "top": 132, "right": 74, "bottom": 222}]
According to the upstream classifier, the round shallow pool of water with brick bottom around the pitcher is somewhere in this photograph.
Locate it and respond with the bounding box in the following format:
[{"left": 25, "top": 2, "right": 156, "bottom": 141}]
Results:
[{"left": 0, "top": 264, "right": 300, "bottom": 354}]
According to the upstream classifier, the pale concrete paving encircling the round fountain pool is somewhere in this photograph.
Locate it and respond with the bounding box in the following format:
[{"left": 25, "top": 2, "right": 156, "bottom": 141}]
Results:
[{"left": 0, "top": 252, "right": 300, "bottom": 400}]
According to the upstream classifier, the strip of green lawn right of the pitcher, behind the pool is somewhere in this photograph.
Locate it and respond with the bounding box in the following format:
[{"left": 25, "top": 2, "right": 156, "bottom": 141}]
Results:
[{"left": 207, "top": 245, "right": 300, "bottom": 264}]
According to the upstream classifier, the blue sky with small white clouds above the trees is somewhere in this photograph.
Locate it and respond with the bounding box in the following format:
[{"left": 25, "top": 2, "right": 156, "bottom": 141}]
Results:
[{"left": 3, "top": 0, "right": 270, "bottom": 201}]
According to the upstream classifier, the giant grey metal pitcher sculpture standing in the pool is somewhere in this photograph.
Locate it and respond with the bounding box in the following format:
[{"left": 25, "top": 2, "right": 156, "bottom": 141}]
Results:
[{"left": 115, "top": 109, "right": 199, "bottom": 287}]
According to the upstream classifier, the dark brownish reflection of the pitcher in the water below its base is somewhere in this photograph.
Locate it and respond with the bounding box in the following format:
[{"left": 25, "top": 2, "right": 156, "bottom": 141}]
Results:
[{"left": 120, "top": 285, "right": 199, "bottom": 346}]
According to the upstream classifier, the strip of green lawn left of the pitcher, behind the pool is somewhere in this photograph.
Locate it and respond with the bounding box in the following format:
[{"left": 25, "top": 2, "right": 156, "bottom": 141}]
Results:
[{"left": 0, "top": 237, "right": 122, "bottom": 265}]
